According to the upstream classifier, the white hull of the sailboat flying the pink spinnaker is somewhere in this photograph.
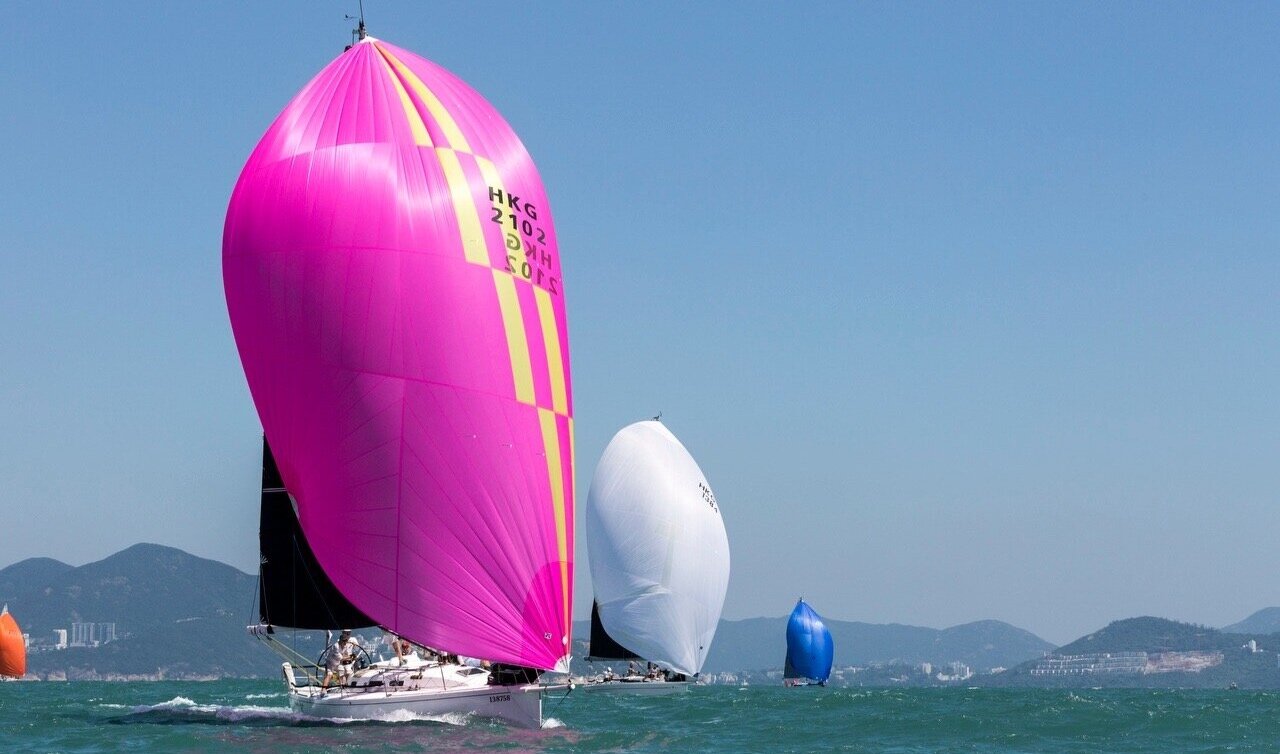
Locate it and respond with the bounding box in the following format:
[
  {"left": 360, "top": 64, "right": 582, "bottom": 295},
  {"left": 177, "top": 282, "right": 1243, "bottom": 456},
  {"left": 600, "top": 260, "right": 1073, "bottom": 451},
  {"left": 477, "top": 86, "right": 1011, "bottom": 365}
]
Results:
[{"left": 284, "top": 663, "right": 556, "bottom": 728}]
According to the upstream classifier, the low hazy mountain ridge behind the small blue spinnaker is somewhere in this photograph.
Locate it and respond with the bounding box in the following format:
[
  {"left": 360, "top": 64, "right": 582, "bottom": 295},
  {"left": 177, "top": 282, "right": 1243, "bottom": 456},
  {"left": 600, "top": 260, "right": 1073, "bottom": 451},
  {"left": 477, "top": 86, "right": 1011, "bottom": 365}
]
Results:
[{"left": 573, "top": 617, "right": 1053, "bottom": 673}]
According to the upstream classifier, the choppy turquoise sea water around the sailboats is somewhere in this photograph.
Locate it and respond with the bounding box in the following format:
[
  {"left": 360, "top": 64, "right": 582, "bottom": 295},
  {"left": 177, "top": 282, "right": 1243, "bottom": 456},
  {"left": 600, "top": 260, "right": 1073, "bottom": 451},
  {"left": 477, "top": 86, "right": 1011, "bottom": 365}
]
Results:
[{"left": 0, "top": 681, "right": 1280, "bottom": 754}]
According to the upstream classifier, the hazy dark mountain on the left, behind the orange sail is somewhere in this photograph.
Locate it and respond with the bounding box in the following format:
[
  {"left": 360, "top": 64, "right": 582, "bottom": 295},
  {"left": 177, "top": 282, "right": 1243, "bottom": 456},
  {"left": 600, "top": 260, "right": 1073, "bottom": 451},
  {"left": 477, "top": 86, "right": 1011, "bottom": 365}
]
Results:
[{"left": 0, "top": 544, "right": 279, "bottom": 677}]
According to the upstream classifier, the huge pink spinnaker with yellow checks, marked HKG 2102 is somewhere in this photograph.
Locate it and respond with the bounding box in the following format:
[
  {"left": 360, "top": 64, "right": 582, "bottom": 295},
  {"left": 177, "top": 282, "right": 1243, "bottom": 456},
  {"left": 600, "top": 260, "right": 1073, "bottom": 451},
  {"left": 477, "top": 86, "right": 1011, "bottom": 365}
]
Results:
[{"left": 223, "top": 38, "right": 573, "bottom": 670}]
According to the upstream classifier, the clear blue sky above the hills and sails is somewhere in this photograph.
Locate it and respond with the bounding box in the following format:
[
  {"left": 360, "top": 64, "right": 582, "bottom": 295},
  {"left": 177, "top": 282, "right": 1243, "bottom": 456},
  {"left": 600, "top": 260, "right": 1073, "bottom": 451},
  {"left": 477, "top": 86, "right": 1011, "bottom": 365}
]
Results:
[{"left": 0, "top": 0, "right": 1280, "bottom": 641}]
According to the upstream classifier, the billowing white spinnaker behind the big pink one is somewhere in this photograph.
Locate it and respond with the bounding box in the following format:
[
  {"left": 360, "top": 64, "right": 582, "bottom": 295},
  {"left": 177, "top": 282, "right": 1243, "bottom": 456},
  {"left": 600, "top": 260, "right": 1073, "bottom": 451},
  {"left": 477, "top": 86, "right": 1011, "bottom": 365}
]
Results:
[{"left": 586, "top": 421, "right": 728, "bottom": 676}]
